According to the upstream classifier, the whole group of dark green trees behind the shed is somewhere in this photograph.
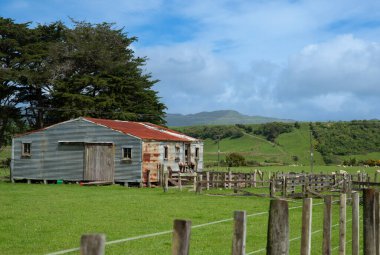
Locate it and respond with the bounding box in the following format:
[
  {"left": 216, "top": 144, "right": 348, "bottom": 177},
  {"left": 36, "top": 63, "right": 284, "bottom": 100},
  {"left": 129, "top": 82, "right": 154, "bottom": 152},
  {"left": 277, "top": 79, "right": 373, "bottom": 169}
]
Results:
[{"left": 0, "top": 17, "right": 166, "bottom": 148}]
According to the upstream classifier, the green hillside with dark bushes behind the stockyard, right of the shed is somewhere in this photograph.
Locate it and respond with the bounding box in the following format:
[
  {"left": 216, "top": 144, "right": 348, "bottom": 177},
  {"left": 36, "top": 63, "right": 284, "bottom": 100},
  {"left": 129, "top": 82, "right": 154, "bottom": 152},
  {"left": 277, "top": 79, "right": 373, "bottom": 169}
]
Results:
[{"left": 178, "top": 121, "right": 380, "bottom": 166}]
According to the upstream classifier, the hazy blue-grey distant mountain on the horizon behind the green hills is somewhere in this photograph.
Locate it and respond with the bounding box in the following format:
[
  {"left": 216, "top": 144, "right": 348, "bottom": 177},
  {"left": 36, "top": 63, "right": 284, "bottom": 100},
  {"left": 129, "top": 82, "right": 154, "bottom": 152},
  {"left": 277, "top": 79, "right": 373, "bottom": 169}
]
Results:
[{"left": 165, "top": 110, "right": 293, "bottom": 127}]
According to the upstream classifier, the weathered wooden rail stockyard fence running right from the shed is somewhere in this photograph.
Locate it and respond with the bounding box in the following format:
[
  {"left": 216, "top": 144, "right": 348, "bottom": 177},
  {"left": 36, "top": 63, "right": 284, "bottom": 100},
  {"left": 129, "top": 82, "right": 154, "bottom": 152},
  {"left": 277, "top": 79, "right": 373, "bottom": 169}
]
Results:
[{"left": 161, "top": 170, "right": 380, "bottom": 198}]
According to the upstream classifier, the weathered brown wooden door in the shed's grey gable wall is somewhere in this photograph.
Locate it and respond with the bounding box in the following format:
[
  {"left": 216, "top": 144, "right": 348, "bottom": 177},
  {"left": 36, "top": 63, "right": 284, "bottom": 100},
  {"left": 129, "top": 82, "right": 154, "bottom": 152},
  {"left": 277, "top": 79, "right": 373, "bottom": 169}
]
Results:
[{"left": 83, "top": 144, "right": 115, "bottom": 181}]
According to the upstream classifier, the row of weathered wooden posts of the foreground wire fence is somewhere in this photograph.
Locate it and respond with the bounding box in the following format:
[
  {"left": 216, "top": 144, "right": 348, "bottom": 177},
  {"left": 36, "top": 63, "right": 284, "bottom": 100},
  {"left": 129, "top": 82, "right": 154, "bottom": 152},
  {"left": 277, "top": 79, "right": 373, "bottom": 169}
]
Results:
[{"left": 80, "top": 189, "right": 380, "bottom": 255}]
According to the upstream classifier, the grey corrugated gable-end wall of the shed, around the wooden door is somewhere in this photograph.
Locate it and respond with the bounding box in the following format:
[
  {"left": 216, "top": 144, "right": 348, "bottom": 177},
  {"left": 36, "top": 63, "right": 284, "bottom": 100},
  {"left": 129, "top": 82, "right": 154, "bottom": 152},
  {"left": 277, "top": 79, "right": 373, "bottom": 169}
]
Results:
[{"left": 12, "top": 118, "right": 142, "bottom": 182}]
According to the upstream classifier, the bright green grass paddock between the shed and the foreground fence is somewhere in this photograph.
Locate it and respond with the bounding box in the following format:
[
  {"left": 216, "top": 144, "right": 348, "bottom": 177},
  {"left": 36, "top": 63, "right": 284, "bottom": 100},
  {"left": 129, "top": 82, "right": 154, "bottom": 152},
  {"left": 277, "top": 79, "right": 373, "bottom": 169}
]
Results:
[{"left": 0, "top": 182, "right": 362, "bottom": 254}]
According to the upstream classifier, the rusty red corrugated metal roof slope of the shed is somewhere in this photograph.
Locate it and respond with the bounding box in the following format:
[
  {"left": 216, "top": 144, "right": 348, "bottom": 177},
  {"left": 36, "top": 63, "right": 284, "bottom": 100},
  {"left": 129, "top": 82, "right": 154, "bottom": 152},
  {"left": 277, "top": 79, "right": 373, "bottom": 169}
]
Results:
[{"left": 83, "top": 117, "right": 197, "bottom": 142}]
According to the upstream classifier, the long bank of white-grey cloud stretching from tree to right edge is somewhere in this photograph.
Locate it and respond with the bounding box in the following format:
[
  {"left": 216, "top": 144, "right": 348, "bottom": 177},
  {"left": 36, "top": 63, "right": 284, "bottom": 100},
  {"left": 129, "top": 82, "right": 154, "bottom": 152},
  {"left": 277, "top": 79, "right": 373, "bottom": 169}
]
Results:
[{"left": 137, "top": 35, "right": 380, "bottom": 120}]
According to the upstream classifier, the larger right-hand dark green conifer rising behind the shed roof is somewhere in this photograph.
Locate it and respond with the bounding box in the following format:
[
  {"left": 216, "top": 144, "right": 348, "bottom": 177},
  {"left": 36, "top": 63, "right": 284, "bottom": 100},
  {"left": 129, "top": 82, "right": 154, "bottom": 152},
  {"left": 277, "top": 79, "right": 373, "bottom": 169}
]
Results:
[{"left": 52, "top": 22, "right": 166, "bottom": 124}]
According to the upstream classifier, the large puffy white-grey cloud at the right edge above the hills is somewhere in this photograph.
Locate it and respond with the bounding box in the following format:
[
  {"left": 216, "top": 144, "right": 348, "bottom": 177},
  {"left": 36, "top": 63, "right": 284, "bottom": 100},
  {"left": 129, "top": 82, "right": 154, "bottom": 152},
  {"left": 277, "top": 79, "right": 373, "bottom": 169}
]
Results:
[{"left": 275, "top": 35, "right": 380, "bottom": 120}]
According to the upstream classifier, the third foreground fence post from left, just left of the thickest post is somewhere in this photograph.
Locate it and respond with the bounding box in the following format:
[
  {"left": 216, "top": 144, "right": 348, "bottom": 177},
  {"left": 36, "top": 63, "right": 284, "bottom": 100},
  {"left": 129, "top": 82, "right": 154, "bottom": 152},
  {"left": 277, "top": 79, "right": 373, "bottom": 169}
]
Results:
[{"left": 232, "top": 211, "right": 247, "bottom": 255}]
